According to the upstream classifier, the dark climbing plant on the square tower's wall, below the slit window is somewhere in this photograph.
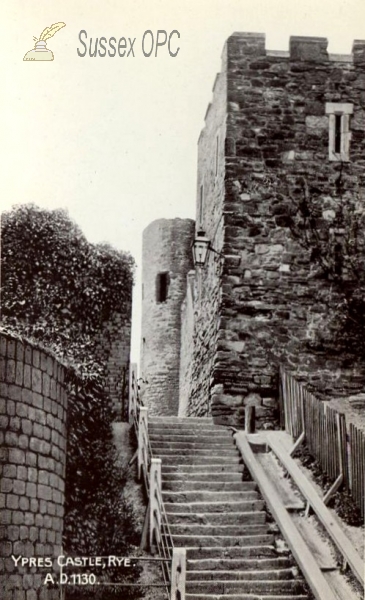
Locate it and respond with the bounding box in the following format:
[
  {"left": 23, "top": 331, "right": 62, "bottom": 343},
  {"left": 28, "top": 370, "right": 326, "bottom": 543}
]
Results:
[{"left": 289, "top": 165, "right": 365, "bottom": 357}]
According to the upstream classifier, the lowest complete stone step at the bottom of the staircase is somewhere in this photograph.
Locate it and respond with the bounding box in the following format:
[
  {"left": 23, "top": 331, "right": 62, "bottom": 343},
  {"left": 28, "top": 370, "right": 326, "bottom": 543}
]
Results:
[{"left": 186, "top": 579, "right": 308, "bottom": 600}]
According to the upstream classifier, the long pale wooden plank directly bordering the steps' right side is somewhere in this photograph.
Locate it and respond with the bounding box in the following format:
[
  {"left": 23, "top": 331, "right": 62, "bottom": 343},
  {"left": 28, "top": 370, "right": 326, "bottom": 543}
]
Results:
[{"left": 234, "top": 432, "right": 336, "bottom": 600}]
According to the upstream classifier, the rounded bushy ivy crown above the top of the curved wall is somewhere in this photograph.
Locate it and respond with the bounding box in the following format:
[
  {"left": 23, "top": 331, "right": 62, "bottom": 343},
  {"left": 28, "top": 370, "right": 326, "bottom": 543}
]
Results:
[{"left": 1, "top": 204, "right": 134, "bottom": 373}]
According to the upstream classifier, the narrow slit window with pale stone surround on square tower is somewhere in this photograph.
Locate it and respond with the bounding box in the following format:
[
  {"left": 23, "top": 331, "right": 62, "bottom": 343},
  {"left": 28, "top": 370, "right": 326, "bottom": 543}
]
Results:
[{"left": 326, "top": 102, "right": 354, "bottom": 162}]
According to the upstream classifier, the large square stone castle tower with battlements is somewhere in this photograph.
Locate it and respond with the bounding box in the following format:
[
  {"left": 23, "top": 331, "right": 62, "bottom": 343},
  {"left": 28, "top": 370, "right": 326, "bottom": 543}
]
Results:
[{"left": 143, "top": 33, "right": 365, "bottom": 426}]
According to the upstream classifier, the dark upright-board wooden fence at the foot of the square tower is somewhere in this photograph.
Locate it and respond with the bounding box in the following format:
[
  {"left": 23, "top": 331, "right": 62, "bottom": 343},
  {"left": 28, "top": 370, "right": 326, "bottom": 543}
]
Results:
[{"left": 280, "top": 369, "right": 365, "bottom": 517}]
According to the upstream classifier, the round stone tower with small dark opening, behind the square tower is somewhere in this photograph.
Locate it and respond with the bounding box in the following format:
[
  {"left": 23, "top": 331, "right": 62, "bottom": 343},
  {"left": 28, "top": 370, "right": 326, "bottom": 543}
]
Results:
[{"left": 141, "top": 219, "right": 195, "bottom": 415}]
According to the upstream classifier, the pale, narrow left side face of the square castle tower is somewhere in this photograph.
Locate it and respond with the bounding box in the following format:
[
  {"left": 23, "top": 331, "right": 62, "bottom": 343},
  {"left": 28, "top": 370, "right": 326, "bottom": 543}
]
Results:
[{"left": 182, "top": 73, "right": 227, "bottom": 416}]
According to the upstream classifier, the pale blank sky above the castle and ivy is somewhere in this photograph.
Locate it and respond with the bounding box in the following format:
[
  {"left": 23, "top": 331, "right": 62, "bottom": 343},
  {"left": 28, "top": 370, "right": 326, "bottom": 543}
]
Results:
[{"left": 0, "top": 0, "right": 365, "bottom": 360}]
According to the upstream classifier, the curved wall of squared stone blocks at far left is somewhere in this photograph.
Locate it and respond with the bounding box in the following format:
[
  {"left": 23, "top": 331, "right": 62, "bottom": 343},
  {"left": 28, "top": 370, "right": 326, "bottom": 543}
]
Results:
[{"left": 0, "top": 334, "right": 67, "bottom": 600}]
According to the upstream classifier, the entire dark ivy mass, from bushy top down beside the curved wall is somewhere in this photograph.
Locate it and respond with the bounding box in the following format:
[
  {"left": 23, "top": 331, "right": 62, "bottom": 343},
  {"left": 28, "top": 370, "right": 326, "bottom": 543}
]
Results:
[{"left": 1, "top": 204, "right": 140, "bottom": 598}]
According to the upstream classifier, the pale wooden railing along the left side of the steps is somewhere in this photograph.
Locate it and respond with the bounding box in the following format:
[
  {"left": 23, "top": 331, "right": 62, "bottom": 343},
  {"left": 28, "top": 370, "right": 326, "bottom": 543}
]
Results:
[{"left": 129, "top": 365, "right": 186, "bottom": 600}]
